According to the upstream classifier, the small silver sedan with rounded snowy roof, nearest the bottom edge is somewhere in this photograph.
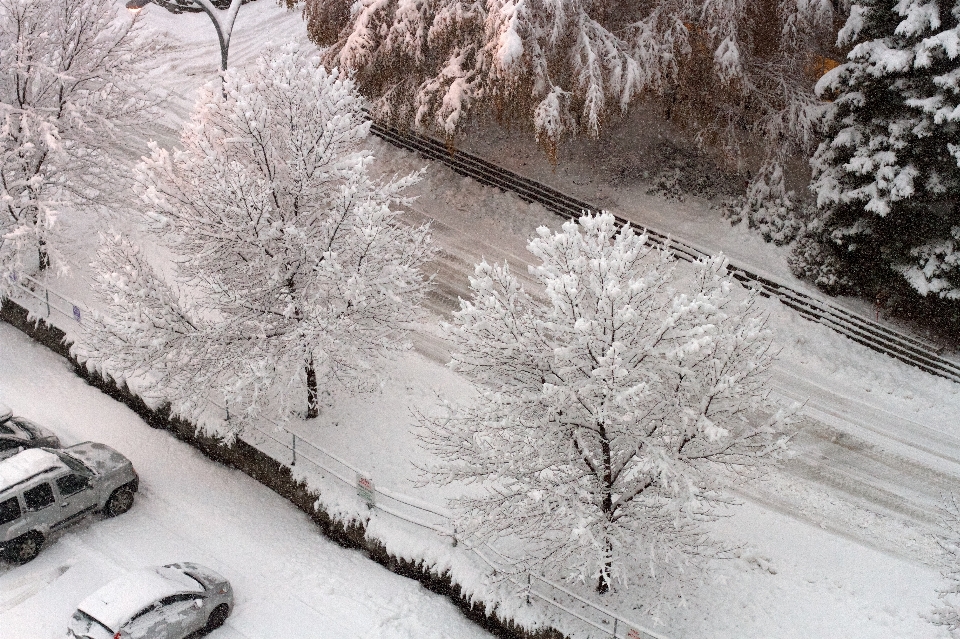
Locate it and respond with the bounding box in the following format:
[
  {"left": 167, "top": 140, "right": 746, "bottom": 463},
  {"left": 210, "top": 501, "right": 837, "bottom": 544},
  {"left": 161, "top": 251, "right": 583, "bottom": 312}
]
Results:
[{"left": 67, "top": 562, "right": 233, "bottom": 639}]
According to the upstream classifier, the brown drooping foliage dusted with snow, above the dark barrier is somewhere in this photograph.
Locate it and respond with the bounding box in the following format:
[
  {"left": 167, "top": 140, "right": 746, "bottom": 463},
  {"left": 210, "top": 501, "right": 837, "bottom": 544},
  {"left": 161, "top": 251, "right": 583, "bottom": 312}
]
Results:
[{"left": 305, "top": 0, "right": 832, "bottom": 174}]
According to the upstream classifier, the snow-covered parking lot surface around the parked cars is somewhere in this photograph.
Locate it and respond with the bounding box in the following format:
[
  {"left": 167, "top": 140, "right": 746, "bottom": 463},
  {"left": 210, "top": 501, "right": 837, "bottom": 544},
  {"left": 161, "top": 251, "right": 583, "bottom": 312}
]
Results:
[{"left": 0, "top": 324, "right": 489, "bottom": 639}]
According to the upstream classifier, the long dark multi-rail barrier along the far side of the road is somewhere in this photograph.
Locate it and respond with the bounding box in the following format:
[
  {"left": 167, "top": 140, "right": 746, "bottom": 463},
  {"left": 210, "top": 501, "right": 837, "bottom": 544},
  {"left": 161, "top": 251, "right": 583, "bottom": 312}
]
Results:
[{"left": 370, "top": 123, "right": 960, "bottom": 383}]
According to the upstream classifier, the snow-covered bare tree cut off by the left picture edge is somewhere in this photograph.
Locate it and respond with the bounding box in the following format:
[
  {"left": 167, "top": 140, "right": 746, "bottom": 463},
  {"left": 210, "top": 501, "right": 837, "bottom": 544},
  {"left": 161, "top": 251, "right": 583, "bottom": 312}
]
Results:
[{"left": 0, "top": 0, "right": 155, "bottom": 288}]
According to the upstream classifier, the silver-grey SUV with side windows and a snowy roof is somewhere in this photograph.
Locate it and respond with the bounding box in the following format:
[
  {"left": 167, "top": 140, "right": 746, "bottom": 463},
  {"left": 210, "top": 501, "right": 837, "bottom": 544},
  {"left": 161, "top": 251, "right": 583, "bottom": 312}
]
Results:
[{"left": 0, "top": 442, "right": 140, "bottom": 564}]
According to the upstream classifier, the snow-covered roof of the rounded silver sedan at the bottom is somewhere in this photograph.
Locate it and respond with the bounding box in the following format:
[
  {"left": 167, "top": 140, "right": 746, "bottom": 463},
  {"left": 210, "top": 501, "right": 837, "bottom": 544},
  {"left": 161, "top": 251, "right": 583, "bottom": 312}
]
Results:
[{"left": 77, "top": 567, "right": 203, "bottom": 631}]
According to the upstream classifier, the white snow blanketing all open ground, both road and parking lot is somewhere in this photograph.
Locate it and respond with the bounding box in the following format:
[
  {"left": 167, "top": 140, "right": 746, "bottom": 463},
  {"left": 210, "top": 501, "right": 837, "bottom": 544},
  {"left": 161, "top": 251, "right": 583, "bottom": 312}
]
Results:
[{"left": 0, "top": 1, "right": 960, "bottom": 639}]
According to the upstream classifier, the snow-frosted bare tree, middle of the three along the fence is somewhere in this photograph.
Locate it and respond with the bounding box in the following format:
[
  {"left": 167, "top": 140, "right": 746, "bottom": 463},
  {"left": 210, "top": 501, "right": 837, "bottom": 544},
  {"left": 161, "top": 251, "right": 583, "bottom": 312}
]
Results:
[{"left": 84, "top": 45, "right": 432, "bottom": 433}]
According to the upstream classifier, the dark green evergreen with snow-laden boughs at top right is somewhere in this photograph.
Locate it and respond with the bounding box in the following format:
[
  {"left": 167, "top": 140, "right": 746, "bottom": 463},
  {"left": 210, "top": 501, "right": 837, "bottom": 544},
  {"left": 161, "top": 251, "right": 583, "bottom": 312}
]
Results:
[{"left": 794, "top": 0, "right": 960, "bottom": 300}]
